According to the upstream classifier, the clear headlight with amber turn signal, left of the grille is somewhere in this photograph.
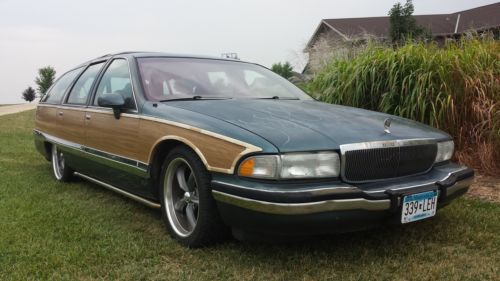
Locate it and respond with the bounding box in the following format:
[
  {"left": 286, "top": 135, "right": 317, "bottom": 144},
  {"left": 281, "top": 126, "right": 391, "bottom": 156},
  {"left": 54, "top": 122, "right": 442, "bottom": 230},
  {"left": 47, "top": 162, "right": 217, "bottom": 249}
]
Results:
[{"left": 238, "top": 152, "right": 340, "bottom": 179}]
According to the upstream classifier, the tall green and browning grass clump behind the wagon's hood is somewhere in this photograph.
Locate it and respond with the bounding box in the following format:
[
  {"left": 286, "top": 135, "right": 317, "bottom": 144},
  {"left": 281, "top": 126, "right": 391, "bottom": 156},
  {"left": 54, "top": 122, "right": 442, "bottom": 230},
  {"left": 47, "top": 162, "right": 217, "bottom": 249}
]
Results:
[{"left": 307, "top": 36, "right": 500, "bottom": 174}]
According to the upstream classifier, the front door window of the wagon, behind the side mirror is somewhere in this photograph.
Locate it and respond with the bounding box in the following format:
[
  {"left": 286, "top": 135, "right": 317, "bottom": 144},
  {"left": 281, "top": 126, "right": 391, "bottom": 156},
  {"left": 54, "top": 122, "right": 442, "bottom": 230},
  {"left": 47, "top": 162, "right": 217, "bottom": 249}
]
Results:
[{"left": 93, "top": 59, "right": 136, "bottom": 109}]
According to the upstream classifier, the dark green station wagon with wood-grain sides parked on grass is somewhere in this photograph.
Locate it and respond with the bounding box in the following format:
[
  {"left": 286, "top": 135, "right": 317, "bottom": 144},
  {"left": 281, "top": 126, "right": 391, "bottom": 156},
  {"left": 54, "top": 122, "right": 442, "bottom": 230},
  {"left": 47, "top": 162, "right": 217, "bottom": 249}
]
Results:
[{"left": 34, "top": 52, "right": 474, "bottom": 247}]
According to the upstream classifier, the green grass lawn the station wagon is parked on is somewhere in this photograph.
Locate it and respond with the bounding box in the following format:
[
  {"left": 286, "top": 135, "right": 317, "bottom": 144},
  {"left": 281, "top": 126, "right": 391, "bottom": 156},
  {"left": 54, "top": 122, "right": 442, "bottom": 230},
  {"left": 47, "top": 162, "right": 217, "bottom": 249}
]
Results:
[{"left": 0, "top": 111, "right": 500, "bottom": 281}]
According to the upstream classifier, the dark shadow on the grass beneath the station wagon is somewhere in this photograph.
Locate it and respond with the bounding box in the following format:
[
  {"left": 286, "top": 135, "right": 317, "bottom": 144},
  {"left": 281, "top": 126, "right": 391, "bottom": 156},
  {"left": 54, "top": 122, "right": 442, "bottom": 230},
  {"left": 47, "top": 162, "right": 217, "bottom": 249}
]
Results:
[{"left": 68, "top": 171, "right": 454, "bottom": 258}]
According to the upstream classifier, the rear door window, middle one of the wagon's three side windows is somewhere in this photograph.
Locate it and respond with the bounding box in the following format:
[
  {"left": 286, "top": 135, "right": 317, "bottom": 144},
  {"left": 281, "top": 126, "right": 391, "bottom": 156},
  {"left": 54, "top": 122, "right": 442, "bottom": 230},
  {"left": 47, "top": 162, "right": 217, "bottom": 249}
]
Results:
[{"left": 67, "top": 62, "right": 104, "bottom": 105}]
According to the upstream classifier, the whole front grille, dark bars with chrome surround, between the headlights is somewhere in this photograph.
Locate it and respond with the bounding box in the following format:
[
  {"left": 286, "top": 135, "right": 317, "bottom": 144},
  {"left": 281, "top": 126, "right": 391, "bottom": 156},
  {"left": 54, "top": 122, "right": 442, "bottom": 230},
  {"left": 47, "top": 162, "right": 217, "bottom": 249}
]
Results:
[{"left": 340, "top": 140, "right": 437, "bottom": 182}]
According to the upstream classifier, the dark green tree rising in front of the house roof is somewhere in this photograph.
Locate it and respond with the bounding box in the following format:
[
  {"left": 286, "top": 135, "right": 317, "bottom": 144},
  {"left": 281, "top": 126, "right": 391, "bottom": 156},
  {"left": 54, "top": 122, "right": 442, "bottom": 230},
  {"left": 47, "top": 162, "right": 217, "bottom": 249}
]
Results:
[{"left": 389, "top": 0, "right": 429, "bottom": 44}]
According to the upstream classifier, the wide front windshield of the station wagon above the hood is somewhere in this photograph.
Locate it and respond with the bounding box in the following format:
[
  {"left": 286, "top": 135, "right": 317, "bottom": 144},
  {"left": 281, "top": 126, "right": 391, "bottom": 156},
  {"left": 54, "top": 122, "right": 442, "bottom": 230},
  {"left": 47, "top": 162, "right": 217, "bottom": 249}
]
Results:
[{"left": 138, "top": 57, "right": 311, "bottom": 101}]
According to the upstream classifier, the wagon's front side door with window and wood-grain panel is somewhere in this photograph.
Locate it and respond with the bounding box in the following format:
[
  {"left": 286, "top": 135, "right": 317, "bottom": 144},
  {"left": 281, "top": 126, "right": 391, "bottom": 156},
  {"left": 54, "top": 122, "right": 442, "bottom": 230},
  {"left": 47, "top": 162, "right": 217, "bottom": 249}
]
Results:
[{"left": 84, "top": 59, "right": 147, "bottom": 195}]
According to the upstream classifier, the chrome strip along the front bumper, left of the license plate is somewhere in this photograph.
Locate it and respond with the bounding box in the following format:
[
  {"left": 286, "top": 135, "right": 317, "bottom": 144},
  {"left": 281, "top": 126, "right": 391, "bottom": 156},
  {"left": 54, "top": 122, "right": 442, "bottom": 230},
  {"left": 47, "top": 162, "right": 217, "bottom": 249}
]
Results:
[{"left": 212, "top": 190, "right": 391, "bottom": 215}]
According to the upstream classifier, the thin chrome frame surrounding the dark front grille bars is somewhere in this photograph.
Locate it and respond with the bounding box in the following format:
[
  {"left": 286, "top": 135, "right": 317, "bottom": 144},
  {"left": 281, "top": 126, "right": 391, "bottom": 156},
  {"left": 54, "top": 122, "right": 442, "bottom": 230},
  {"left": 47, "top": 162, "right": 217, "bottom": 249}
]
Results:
[{"left": 339, "top": 138, "right": 437, "bottom": 183}]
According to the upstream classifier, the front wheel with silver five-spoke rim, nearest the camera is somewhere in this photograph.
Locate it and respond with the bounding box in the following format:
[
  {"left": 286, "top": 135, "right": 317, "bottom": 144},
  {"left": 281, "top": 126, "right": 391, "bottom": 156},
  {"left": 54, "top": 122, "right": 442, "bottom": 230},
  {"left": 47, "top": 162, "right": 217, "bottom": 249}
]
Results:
[{"left": 160, "top": 146, "right": 228, "bottom": 247}]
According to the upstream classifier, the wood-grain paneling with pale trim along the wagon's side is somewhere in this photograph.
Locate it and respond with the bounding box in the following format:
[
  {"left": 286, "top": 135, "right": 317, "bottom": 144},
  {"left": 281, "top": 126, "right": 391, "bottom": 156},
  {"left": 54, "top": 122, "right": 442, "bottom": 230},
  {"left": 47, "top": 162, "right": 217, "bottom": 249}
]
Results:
[{"left": 36, "top": 105, "right": 261, "bottom": 173}]
